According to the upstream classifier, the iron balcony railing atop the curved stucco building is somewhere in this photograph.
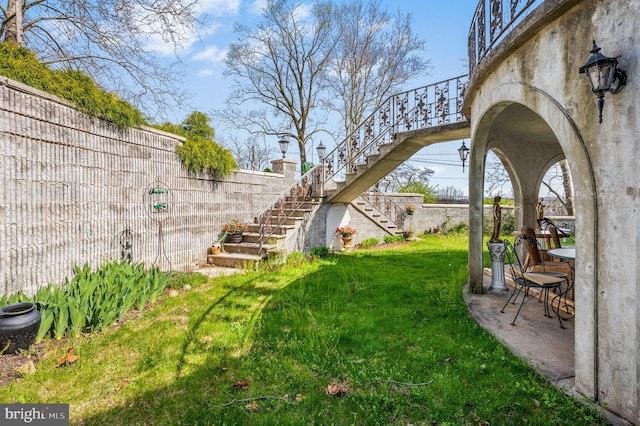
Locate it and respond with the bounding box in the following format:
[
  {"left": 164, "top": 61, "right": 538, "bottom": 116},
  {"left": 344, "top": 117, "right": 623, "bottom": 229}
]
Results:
[{"left": 468, "top": 0, "right": 544, "bottom": 73}]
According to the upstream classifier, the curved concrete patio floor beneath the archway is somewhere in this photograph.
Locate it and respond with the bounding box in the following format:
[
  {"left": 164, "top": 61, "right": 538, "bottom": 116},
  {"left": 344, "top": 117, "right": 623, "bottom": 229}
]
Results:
[{"left": 464, "top": 271, "right": 630, "bottom": 426}]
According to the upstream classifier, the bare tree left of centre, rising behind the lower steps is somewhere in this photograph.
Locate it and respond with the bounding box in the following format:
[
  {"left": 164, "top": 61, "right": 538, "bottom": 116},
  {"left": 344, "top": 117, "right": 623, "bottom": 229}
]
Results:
[{"left": 214, "top": 0, "right": 335, "bottom": 173}]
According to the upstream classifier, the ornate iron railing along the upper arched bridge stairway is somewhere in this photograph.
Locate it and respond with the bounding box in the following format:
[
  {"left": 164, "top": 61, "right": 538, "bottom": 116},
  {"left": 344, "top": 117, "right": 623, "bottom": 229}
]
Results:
[{"left": 323, "top": 75, "right": 469, "bottom": 182}]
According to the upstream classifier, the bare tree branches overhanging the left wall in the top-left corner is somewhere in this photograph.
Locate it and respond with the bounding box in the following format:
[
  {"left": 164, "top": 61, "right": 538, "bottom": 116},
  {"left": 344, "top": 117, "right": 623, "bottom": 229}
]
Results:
[{"left": 0, "top": 0, "right": 200, "bottom": 117}]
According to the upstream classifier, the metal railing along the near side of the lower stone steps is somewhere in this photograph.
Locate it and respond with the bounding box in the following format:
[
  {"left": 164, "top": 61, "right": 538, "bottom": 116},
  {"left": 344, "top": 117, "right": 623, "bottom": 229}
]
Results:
[{"left": 256, "top": 165, "right": 322, "bottom": 253}]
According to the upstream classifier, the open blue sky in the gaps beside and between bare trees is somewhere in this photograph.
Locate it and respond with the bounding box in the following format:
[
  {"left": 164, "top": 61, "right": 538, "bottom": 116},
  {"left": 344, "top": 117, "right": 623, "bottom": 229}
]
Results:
[{"left": 152, "top": 0, "right": 478, "bottom": 193}]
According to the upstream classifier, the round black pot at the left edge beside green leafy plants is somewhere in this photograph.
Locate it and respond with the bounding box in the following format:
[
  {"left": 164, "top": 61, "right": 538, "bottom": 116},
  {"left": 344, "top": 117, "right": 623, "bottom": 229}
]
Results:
[{"left": 0, "top": 302, "right": 40, "bottom": 354}]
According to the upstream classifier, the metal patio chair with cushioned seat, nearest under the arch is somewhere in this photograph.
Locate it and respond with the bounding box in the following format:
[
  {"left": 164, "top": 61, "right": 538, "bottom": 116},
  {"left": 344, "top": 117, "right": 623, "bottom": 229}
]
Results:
[{"left": 500, "top": 235, "right": 568, "bottom": 328}]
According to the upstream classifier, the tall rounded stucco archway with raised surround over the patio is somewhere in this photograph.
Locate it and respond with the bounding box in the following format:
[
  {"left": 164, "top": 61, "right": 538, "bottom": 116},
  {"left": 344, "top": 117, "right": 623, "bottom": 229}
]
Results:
[{"left": 469, "top": 90, "right": 597, "bottom": 400}]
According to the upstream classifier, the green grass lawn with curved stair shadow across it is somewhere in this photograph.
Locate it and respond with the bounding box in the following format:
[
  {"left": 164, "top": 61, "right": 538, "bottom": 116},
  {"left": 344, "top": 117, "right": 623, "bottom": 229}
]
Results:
[{"left": 0, "top": 236, "right": 605, "bottom": 425}]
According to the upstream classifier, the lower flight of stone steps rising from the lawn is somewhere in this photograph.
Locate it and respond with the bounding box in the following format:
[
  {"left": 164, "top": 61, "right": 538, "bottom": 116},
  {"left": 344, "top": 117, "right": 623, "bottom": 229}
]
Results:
[{"left": 207, "top": 197, "right": 322, "bottom": 269}]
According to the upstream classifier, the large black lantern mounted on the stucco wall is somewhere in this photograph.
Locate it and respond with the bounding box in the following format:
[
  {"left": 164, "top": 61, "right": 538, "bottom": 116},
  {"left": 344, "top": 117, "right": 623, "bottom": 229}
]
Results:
[{"left": 580, "top": 40, "right": 627, "bottom": 123}]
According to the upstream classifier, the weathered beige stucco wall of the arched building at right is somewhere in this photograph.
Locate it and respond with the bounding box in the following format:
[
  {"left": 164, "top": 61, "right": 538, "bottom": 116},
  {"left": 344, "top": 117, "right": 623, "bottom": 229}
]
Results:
[{"left": 466, "top": 0, "right": 640, "bottom": 423}]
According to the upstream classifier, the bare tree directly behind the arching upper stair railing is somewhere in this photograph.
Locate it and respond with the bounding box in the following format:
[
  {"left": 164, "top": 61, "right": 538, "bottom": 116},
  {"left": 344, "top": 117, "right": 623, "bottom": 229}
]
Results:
[{"left": 326, "top": 0, "right": 429, "bottom": 141}]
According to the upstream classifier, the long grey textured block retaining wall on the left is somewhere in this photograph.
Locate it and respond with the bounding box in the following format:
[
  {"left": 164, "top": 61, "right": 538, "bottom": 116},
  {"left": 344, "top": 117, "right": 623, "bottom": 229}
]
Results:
[{"left": 0, "top": 77, "right": 288, "bottom": 294}]
